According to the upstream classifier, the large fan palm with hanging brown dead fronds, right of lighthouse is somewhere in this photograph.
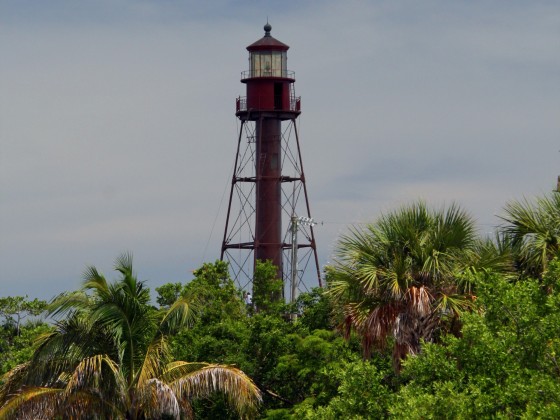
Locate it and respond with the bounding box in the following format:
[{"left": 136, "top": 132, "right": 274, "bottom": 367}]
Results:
[{"left": 327, "top": 202, "right": 507, "bottom": 370}]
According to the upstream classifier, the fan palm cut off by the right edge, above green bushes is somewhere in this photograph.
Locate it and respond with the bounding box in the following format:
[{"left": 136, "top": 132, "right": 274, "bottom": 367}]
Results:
[{"left": 500, "top": 192, "right": 560, "bottom": 277}]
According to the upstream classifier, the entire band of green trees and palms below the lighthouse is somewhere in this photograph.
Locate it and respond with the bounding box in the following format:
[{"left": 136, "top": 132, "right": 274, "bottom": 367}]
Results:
[{"left": 0, "top": 193, "right": 560, "bottom": 420}]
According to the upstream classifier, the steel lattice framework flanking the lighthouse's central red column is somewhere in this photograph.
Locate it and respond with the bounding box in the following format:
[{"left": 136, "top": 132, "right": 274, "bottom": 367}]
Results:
[{"left": 221, "top": 115, "right": 322, "bottom": 292}]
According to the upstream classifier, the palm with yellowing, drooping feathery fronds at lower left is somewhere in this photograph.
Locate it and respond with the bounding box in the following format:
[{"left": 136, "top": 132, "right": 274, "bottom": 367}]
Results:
[{"left": 0, "top": 254, "right": 261, "bottom": 419}]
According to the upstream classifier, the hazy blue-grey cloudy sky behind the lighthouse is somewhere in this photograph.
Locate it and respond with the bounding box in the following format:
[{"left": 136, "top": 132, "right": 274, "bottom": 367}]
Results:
[{"left": 0, "top": 0, "right": 560, "bottom": 299}]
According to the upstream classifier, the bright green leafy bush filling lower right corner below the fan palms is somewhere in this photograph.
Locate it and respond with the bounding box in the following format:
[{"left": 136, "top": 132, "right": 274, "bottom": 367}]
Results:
[{"left": 389, "top": 262, "right": 560, "bottom": 418}]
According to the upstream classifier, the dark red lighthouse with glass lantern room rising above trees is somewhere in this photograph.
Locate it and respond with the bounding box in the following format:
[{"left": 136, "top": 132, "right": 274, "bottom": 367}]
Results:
[{"left": 221, "top": 23, "right": 321, "bottom": 298}]
